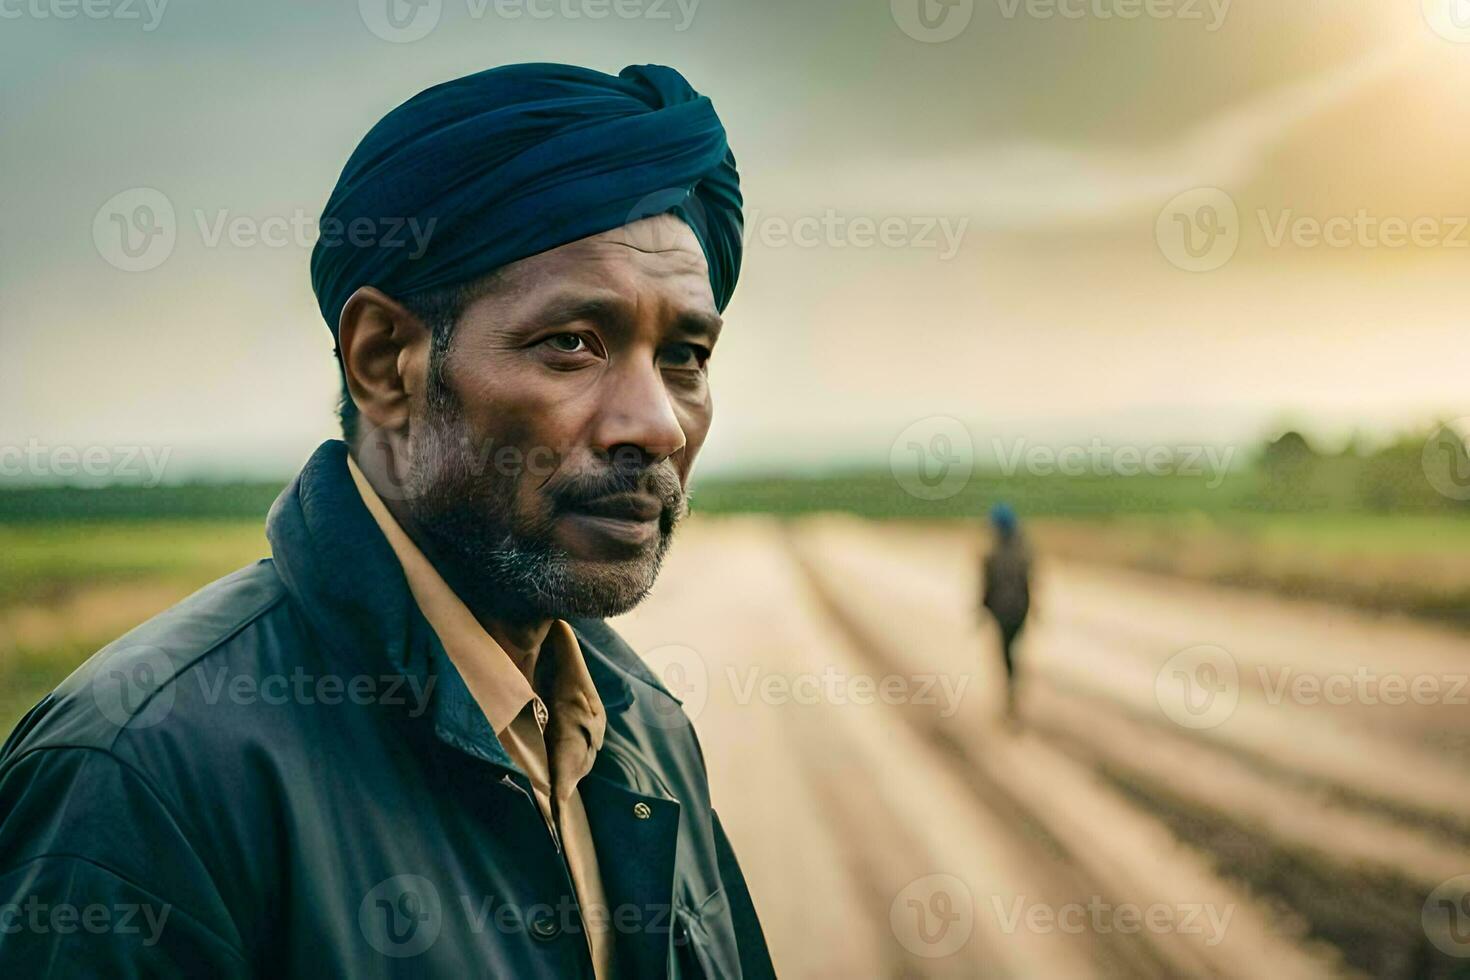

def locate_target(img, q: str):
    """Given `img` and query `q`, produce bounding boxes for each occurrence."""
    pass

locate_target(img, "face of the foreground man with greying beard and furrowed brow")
[406,215,720,617]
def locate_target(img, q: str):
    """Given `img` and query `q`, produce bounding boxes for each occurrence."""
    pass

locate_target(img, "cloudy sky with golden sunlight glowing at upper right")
[0,0,1470,482]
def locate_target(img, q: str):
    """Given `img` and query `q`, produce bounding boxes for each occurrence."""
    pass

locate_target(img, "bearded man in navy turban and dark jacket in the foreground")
[0,65,773,980]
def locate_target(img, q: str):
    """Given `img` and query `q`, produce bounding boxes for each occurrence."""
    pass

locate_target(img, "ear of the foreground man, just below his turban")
[337,287,431,433]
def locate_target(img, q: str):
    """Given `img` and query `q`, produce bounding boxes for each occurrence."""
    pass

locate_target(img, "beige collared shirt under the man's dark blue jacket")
[347,457,614,980]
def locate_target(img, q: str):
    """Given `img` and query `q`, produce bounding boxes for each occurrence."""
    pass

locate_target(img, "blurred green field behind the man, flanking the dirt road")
[0,457,1470,730]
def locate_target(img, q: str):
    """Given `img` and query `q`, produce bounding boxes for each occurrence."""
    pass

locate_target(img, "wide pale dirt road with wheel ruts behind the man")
[617,517,1470,977]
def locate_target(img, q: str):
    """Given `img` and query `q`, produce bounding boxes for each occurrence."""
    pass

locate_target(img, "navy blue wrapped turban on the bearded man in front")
[312,65,742,335]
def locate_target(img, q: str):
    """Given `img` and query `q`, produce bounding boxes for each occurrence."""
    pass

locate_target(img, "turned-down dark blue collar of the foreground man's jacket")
[266,439,637,768]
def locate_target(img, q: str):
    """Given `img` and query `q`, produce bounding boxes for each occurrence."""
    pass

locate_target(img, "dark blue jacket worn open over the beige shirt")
[0,442,773,980]
